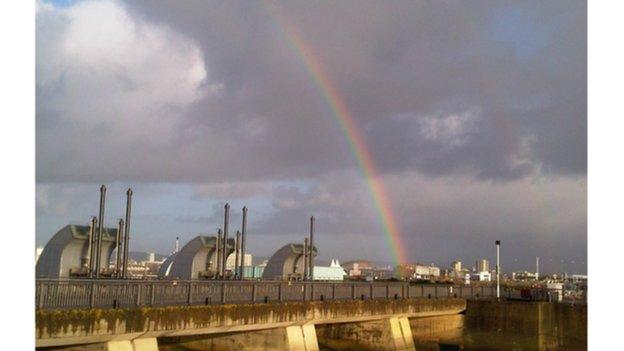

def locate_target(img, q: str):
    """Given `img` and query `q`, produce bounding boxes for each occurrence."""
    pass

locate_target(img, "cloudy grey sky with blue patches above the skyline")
[36,0,587,273]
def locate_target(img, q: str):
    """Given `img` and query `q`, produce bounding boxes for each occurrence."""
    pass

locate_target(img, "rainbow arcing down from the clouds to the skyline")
[264,1,407,264]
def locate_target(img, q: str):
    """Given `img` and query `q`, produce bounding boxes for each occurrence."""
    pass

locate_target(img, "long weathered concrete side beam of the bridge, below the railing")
[36,299,466,347]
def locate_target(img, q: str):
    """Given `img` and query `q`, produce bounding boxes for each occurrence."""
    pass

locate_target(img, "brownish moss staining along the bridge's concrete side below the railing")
[36,298,466,339]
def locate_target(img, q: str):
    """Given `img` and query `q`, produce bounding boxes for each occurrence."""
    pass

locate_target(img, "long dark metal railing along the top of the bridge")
[35,279,496,309]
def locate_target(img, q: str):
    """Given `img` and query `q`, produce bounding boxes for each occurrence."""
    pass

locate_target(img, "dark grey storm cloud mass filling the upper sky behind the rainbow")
[37,1,587,182]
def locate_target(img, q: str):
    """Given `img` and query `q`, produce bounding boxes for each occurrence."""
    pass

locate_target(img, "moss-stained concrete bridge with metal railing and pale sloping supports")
[36,280,493,351]
